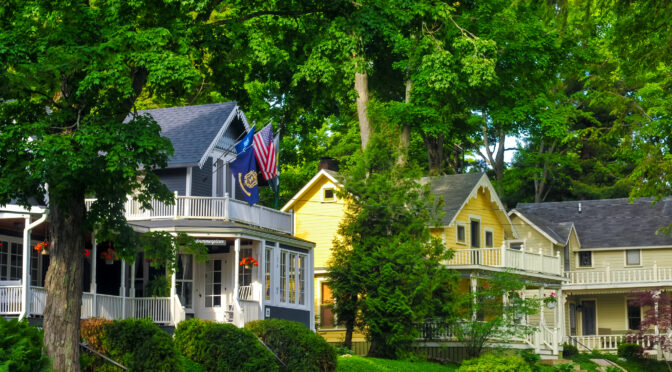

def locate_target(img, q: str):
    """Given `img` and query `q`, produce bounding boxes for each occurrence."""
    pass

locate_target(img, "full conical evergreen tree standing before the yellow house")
[329,128,456,358]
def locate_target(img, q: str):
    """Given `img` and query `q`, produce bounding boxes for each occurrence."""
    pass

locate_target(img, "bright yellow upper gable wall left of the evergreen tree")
[293,176,344,270]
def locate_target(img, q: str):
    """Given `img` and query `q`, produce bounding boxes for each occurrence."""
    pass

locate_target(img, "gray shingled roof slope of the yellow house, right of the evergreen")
[420,173,483,225]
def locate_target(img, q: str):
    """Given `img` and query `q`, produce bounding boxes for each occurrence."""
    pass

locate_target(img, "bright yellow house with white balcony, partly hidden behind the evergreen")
[282,169,564,355]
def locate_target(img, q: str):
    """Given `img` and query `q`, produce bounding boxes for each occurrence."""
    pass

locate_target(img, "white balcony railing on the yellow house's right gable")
[448,247,562,276]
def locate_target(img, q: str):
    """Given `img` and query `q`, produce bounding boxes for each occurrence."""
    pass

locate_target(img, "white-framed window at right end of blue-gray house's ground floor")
[280,250,308,305]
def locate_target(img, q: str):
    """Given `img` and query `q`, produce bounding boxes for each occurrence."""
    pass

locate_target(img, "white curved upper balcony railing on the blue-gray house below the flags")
[86,193,293,234]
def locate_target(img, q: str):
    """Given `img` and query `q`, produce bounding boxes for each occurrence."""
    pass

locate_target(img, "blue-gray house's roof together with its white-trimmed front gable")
[138,102,250,168]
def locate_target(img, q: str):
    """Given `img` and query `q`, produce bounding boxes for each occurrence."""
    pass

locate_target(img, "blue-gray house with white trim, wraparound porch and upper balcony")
[0,102,315,329]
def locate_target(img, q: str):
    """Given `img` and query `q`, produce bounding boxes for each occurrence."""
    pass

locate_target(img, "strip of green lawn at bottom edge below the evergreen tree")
[336,355,458,372]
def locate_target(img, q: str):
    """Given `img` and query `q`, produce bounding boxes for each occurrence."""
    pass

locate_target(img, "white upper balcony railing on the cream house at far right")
[567,264,672,285]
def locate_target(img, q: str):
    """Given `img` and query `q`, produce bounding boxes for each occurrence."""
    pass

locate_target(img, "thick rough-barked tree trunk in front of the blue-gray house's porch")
[44,190,86,372]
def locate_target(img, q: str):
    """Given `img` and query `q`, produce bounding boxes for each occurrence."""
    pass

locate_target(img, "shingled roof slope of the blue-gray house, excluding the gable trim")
[133,102,236,168]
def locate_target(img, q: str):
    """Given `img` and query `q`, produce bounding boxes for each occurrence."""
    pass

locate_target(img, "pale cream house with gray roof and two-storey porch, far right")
[509,198,672,350]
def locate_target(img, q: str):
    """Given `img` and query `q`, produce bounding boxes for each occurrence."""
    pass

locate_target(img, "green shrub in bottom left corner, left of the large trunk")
[0,316,50,372]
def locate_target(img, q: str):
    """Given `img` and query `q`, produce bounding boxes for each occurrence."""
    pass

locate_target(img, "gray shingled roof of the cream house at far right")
[516,197,672,248]
